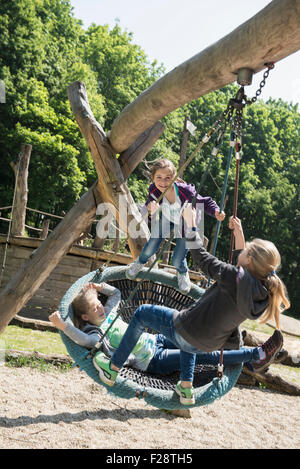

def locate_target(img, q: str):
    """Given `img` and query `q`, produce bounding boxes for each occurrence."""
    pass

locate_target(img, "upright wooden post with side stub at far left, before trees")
[10,144,32,236]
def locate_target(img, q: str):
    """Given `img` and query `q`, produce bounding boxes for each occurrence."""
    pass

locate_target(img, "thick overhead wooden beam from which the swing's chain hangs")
[109,0,300,153]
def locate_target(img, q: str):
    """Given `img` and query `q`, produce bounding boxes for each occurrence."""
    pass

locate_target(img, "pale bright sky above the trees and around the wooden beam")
[70,0,300,105]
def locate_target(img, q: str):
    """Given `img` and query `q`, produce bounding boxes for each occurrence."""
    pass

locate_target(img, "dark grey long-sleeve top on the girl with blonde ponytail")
[174,230,269,352]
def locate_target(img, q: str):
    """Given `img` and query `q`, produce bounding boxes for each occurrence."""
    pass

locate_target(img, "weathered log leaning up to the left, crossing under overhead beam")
[68,81,149,258]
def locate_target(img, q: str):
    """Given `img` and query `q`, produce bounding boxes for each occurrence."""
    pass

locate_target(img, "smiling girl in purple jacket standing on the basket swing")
[127,159,225,293]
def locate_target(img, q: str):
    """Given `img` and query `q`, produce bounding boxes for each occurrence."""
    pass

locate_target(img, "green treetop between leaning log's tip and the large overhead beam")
[84,24,163,130]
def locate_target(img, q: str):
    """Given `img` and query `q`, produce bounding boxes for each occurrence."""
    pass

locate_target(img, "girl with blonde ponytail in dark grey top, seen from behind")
[94,206,289,405]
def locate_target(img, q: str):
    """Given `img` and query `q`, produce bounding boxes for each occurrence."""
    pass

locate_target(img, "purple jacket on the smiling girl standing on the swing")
[145,182,220,217]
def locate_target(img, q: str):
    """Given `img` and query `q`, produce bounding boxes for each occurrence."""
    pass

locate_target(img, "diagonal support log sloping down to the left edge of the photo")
[0,184,101,334]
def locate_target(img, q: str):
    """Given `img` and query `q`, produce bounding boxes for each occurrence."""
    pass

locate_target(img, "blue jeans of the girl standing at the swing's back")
[138,217,188,274]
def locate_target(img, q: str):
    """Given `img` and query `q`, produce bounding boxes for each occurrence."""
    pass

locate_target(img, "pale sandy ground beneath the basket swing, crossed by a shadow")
[0,366,300,449]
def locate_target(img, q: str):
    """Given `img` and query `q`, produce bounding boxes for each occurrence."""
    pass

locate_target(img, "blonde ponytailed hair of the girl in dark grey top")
[246,238,290,329]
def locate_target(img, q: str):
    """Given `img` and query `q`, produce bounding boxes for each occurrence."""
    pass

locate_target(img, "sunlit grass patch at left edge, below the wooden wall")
[0,326,68,355]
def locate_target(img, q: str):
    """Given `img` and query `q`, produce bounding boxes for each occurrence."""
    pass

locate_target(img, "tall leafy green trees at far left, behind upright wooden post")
[0,0,105,213]
